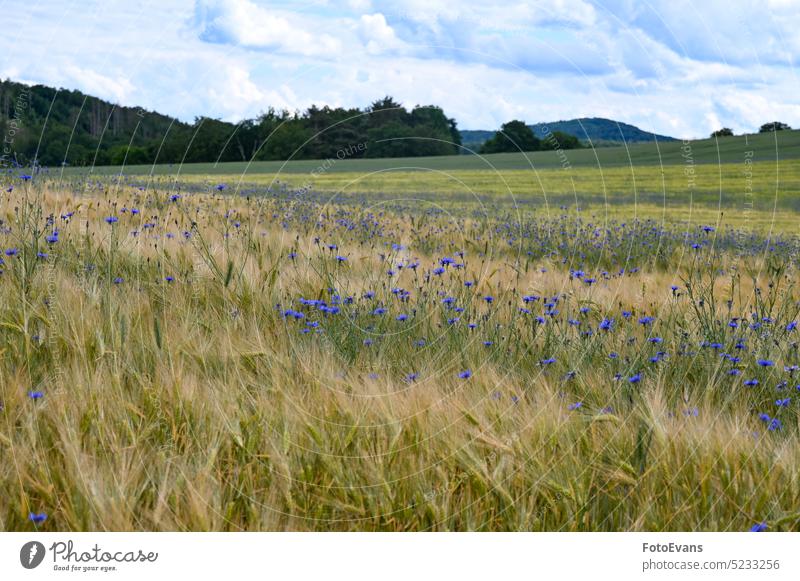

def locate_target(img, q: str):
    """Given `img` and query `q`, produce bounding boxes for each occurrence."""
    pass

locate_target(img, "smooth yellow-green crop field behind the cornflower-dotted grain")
[59,131,800,233]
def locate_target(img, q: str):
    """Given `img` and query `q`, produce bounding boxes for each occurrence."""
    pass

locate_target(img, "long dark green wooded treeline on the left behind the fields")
[0,81,461,166]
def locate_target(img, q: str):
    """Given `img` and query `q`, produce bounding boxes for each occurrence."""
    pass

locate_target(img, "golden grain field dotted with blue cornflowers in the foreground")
[0,174,800,531]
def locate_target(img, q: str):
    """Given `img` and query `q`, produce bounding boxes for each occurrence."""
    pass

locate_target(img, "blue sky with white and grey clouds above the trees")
[0,0,800,138]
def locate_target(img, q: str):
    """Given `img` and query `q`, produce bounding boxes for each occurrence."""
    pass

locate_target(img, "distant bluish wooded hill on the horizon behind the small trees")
[461,117,676,150]
